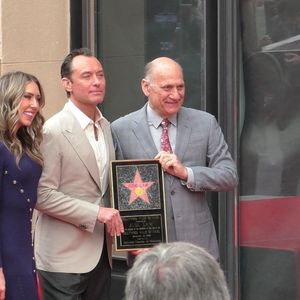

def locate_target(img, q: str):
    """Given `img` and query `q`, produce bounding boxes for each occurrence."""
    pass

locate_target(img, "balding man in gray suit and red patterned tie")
[111,57,238,263]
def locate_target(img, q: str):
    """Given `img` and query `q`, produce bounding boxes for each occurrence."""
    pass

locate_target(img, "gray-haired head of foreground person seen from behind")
[125,242,230,300]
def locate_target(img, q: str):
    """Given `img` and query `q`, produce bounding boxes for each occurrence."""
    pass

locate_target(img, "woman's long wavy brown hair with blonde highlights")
[0,71,45,165]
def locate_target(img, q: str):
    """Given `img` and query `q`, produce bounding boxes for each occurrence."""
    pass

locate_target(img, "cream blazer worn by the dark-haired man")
[35,106,115,273]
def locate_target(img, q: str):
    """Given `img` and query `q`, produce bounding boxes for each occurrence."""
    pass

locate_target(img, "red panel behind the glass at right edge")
[240,197,300,250]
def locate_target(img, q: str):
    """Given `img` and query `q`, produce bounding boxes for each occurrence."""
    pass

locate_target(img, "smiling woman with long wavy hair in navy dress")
[0,71,45,300]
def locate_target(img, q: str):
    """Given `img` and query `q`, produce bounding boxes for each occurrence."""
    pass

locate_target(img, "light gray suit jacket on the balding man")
[111,105,238,258]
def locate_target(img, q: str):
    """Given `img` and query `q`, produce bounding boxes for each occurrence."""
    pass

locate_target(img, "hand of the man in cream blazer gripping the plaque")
[98,207,124,236]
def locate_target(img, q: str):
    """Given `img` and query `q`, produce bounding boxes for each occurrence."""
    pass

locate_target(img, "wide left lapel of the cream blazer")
[63,107,101,190]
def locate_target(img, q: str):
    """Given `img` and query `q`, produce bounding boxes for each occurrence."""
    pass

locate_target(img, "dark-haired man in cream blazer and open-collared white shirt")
[35,49,124,300]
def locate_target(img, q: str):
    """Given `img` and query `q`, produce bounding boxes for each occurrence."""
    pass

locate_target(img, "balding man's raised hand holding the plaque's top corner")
[155,151,188,180]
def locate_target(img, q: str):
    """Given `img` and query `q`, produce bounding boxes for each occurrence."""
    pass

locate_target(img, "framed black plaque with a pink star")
[110,159,167,251]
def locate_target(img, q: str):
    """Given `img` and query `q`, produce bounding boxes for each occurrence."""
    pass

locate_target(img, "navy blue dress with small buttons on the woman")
[0,143,42,300]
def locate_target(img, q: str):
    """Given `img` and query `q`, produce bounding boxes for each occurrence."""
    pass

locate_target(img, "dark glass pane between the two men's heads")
[99,0,146,121]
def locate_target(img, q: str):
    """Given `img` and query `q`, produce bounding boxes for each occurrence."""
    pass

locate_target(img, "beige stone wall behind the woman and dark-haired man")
[0,0,70,118]
